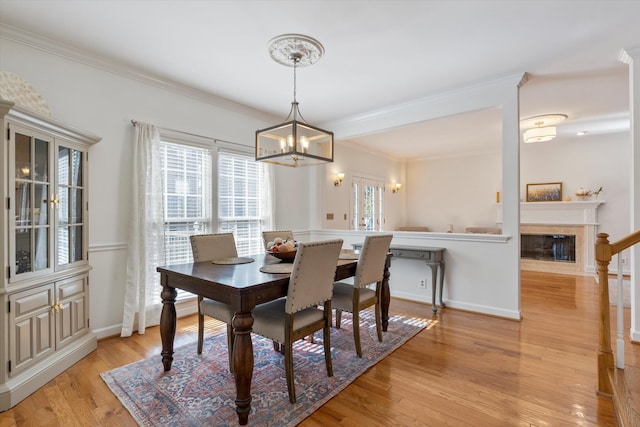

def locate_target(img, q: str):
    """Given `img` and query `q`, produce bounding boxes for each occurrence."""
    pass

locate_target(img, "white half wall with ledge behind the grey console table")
[308,230,520,320]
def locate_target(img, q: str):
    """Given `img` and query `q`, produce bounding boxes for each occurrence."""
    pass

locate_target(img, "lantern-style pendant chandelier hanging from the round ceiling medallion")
[256,34,333,167]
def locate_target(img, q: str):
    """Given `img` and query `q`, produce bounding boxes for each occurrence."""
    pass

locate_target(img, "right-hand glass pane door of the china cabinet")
[57,146,84,266]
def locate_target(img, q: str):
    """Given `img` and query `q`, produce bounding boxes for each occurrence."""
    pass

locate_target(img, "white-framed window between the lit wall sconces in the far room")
[351,176,385,231]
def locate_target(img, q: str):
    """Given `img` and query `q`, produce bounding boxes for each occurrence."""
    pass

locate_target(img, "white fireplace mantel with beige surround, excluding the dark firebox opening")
[497,200,604,275]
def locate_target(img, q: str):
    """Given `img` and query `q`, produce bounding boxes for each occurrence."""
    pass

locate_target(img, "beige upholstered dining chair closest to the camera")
[252,239,342,403]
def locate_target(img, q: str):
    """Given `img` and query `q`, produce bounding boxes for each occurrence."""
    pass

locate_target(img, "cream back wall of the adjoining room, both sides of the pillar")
[403,132,632,244]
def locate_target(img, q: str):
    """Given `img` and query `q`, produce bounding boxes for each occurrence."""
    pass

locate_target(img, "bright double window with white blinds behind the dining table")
[160,141,269,264]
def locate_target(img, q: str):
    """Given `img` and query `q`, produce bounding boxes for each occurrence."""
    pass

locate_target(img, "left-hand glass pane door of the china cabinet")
[13,131,51,275]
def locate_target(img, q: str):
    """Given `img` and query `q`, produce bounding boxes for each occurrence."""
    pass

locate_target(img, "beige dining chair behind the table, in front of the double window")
[189,233,238,372]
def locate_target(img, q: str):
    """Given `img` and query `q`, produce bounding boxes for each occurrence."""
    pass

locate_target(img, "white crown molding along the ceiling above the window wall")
[0,24,281,122]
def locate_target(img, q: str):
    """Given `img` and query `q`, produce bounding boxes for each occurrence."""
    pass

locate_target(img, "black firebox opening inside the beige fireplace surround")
[520,234,576,263]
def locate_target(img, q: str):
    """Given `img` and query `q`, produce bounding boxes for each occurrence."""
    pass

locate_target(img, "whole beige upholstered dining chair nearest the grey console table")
[331,234,393,357]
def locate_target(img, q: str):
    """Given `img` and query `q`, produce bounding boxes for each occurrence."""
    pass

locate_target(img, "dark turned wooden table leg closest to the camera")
[232,312,253,425]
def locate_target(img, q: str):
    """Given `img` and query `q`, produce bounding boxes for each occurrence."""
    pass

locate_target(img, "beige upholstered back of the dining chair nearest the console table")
[353,234,393,288]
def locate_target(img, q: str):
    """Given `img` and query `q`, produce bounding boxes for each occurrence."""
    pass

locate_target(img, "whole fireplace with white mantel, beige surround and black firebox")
[497,200,604,275]
